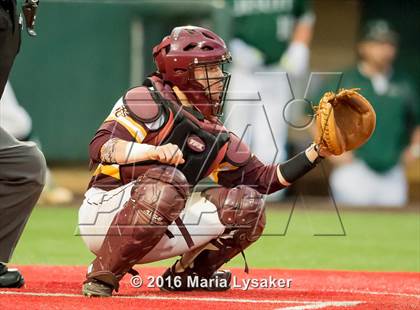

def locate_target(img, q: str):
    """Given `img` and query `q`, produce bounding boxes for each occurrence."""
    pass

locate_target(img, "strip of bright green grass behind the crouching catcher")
[12,207,420,272]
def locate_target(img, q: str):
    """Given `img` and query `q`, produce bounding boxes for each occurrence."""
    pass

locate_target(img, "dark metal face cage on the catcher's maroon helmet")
[188,59,231,117]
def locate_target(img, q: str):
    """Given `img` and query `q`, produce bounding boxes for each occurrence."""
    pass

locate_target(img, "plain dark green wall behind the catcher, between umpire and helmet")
[11,0,229,161]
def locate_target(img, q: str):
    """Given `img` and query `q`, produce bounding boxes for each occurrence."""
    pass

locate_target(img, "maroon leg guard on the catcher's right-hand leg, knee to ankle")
[164,186,265,290]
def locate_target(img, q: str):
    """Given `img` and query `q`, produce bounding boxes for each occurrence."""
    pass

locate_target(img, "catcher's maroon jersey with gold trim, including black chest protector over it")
[89,76,284,194]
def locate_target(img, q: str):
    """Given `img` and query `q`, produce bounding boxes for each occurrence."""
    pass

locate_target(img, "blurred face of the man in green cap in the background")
[359,41,397,69]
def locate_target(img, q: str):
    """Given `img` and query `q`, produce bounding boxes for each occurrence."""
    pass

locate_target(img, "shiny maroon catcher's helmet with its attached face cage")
[153,26,231,116]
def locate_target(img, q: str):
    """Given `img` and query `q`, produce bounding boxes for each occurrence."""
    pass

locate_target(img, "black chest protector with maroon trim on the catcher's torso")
[124,79,230,185]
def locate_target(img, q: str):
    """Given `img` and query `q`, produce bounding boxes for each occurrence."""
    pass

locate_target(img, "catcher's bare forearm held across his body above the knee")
[100,138,155,165]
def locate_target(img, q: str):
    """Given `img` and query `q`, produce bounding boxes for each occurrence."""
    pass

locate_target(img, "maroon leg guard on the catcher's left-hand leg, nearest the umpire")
[87,166,189,290]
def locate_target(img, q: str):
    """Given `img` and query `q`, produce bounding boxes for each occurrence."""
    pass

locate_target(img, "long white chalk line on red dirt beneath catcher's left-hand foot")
[0,291,363,309]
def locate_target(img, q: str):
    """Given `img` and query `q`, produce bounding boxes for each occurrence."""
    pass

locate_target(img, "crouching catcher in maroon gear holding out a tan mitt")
[79,26,374,296]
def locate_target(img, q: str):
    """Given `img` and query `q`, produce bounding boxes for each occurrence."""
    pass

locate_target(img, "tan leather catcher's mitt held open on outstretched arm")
[315,89,376,155]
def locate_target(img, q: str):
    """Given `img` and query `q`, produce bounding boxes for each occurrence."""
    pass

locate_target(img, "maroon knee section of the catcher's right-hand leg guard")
[202,185,265,243]
